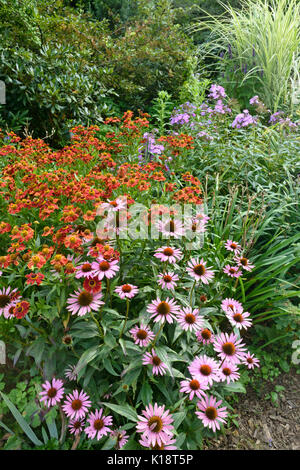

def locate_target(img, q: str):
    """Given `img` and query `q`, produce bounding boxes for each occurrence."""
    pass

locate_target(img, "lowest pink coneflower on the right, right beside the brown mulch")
[196,396,228,432]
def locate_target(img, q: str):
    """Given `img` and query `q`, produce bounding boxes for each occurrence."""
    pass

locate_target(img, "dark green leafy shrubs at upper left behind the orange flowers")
[0,0,192,145]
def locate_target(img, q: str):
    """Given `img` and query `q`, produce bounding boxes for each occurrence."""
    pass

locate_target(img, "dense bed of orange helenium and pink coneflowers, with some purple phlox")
[0,86,298,449]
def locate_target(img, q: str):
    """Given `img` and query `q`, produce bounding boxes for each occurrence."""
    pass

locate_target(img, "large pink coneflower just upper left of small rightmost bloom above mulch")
[214,333,245,364]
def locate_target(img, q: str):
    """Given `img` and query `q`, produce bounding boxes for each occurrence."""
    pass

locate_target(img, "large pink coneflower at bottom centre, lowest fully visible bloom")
[136,403,174,446]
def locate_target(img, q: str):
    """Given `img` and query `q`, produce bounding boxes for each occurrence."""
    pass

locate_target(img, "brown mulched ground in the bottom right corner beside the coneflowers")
[205,371,300,450]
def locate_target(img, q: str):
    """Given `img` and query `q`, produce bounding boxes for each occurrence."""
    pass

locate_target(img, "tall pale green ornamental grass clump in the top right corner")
[195,0,300,111]
